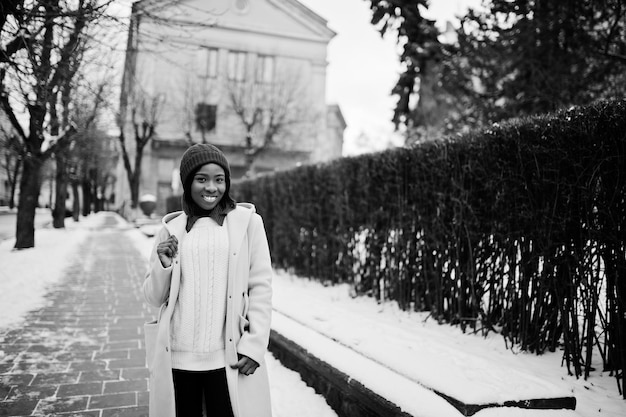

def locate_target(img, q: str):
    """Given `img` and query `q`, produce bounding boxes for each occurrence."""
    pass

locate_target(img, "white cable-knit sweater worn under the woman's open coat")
[171,217,228,371]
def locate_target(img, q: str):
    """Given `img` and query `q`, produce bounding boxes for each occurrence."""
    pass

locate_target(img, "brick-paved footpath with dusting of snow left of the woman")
[0,217,154,417]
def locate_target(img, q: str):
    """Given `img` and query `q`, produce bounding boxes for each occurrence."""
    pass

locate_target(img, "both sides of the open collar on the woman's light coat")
[161,203,256,248]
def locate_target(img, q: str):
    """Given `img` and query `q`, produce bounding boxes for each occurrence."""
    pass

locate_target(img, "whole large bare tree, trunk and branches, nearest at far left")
[0,0,111,249]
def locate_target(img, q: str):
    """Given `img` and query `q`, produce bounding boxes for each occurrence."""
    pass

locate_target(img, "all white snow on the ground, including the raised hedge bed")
[0,214,626,417]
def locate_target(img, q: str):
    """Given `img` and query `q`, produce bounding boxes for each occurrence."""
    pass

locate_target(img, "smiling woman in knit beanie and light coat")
[143,144,272,417]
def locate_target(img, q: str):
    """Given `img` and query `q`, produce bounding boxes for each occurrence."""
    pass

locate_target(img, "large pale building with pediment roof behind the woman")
[116,0,346,214]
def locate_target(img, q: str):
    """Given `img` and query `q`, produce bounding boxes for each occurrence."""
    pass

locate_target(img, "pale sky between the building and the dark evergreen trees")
[299,0,480,156]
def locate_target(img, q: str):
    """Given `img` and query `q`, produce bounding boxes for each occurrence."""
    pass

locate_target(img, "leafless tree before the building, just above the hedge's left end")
[226,69,319,175]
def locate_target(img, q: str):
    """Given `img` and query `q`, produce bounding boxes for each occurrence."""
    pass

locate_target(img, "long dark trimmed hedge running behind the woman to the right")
[234,100,626,394]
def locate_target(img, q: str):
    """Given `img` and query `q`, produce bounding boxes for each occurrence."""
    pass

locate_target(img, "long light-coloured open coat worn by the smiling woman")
[143,203,273,417]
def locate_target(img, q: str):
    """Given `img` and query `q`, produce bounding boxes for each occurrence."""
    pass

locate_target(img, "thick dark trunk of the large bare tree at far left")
[14,156,43,249]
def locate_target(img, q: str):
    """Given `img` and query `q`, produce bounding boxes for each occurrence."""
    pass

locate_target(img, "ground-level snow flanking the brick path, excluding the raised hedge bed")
[0,213,337,417]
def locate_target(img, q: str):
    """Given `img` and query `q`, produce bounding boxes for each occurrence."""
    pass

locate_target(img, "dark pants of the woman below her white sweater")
[172,369,233,417]
